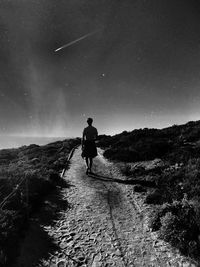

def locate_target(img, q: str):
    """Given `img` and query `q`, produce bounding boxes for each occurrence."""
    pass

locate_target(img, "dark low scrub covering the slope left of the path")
[0,138,80,266]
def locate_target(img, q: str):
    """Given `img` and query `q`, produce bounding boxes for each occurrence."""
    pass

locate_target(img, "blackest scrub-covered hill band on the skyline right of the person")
[99,121,200,162]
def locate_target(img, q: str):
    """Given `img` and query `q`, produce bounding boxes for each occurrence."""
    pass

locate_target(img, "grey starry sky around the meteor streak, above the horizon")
[0,0,200,136]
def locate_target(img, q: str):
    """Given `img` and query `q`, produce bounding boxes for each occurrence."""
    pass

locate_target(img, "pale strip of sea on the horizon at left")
[0,135,66,150]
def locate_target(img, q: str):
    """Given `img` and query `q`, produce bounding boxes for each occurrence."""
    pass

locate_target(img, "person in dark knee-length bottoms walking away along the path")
[82,118,98,174]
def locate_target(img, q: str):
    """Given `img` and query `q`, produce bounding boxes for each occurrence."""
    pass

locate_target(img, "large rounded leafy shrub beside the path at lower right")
[149,198,200,257]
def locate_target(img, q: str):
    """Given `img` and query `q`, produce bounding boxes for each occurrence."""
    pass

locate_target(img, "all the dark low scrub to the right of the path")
[99,121,200,262]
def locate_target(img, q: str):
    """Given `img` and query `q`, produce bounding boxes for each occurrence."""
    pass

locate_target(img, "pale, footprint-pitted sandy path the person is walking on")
[14,148,196,267]
